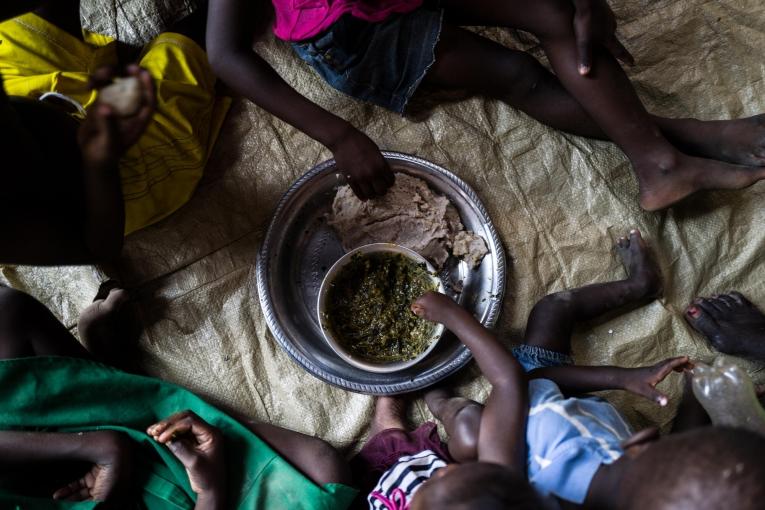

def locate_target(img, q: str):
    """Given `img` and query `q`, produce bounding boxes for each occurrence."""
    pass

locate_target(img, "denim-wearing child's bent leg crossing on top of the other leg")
[424,0,765,210]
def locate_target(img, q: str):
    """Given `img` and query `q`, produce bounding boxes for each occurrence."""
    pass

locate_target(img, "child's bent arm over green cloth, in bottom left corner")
[0,430,131,501]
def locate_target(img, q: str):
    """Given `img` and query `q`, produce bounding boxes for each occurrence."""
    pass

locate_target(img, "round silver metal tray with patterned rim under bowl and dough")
[256,152,505,395]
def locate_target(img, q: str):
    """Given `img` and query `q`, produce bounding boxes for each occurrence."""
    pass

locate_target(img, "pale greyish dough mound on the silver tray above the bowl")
[329,173,488,268]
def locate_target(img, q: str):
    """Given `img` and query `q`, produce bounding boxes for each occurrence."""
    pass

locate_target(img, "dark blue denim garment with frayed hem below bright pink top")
[292,7,443,114]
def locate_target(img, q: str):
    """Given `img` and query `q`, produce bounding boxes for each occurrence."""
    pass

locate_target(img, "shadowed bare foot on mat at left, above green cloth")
[77,288,137,370]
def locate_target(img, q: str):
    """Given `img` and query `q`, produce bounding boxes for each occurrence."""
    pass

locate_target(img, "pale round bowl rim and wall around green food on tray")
[316,243,446,374]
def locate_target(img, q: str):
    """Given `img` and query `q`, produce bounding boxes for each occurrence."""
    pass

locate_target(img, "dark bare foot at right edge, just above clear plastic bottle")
[685,292,765,361]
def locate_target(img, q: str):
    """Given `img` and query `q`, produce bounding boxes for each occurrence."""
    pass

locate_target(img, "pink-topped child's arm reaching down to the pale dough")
[207,0,393,199]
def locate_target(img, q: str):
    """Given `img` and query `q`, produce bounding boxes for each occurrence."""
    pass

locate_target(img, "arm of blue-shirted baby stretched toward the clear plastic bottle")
[528,356,690,406]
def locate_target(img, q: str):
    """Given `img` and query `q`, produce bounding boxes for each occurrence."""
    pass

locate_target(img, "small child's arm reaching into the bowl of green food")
[412,292,528,476]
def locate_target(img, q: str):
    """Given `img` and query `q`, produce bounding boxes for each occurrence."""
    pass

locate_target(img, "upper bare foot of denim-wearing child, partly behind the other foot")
[667,114,765,166]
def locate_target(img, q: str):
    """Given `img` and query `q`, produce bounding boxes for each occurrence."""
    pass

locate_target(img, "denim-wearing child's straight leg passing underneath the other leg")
[426,24,765,166]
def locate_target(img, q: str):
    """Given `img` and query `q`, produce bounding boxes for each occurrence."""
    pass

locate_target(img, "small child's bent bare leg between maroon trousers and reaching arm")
[425,388,483,463]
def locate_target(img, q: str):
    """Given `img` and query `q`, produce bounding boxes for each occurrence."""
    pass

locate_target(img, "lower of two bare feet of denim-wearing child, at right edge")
[634,152,765,211]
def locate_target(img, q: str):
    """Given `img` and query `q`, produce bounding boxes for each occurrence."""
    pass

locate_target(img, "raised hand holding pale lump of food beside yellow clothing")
[77,65,156,166]
